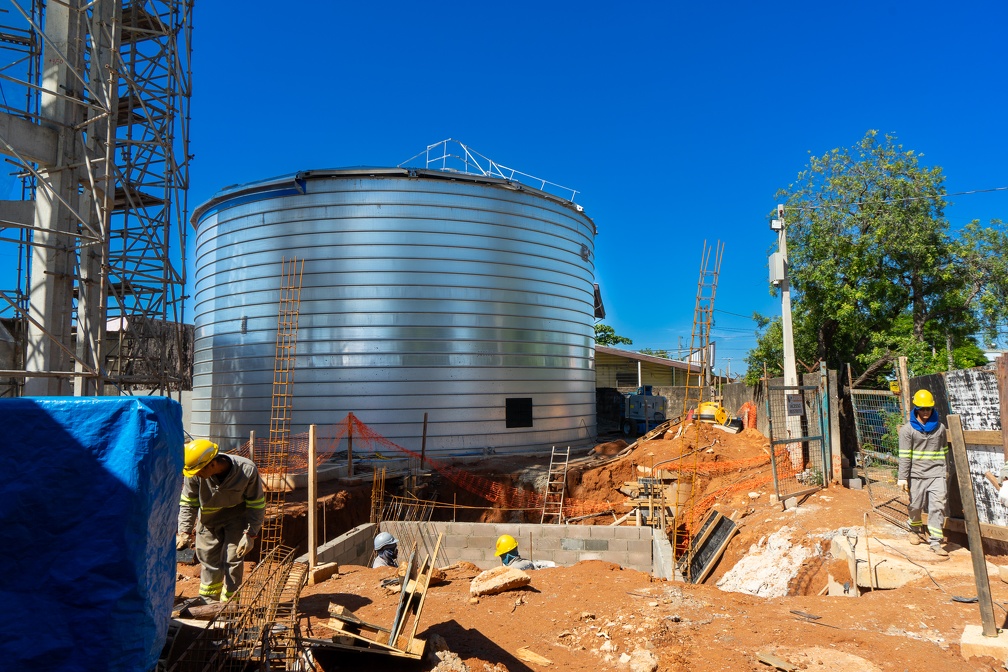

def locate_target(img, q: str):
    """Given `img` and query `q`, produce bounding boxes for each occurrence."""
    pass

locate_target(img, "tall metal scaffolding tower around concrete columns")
[0,0,194,396]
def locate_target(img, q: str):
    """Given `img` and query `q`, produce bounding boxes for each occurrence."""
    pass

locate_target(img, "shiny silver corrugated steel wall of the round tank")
[190,168,596,454]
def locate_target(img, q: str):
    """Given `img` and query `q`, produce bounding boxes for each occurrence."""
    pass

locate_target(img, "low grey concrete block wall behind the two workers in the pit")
[370,521,672,578]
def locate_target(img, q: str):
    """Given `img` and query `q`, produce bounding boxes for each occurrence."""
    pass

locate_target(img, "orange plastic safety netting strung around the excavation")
[235,409,789,530]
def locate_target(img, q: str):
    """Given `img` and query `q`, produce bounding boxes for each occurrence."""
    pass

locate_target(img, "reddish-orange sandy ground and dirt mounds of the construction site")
[176,423,1008,672]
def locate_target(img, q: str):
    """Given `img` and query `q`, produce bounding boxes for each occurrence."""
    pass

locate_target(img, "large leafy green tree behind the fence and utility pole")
[746,131,1008,383]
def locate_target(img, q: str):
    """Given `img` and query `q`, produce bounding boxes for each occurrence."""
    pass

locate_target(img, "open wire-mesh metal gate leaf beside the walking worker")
[851,390,909,527]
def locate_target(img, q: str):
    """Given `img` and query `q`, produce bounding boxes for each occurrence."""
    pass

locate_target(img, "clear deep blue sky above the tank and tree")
[190,0,1008,373]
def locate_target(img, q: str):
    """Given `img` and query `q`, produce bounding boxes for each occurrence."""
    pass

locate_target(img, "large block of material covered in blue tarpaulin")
[0,397,183,672]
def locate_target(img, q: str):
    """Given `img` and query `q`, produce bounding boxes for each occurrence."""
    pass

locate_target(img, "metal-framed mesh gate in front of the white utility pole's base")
[766,374,830,501]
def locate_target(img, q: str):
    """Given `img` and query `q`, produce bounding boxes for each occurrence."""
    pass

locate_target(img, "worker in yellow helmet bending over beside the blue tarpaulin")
[175,438,266,600]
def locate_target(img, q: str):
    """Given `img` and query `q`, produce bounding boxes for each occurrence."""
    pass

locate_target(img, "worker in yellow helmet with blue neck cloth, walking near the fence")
[896,390,949,557]
